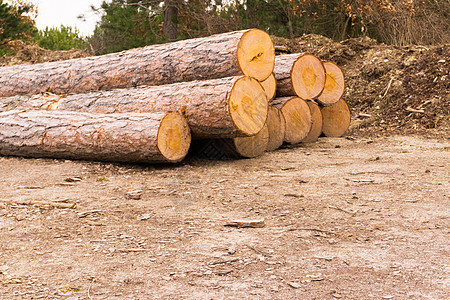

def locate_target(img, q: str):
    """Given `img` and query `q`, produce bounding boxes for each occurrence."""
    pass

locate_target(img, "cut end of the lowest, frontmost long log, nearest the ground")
[157,112,191,162]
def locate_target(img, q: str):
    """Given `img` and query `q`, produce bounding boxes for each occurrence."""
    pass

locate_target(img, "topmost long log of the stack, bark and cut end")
[0,29,275,97]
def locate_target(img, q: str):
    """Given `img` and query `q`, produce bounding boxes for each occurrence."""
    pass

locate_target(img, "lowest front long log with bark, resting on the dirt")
[0,110,191,163]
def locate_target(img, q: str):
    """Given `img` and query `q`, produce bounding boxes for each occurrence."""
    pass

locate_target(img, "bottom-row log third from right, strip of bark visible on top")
[272,97,312,144]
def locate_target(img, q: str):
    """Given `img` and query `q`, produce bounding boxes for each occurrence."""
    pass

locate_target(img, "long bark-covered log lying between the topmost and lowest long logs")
[0,77,268,138]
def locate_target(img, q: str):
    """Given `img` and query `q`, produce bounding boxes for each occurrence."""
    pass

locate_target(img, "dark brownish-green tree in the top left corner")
[0,0,36,47]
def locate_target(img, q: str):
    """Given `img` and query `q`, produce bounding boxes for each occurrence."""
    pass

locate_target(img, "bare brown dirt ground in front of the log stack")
[0,136,450,299]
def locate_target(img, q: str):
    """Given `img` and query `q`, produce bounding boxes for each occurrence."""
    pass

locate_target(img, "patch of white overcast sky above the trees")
[32,0,103,35]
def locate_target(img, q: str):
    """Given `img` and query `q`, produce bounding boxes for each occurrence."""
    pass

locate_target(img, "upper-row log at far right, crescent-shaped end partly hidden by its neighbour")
[317,61,345,106]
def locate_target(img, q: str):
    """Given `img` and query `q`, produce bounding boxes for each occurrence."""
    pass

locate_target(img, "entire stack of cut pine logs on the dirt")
[0,29,350,163]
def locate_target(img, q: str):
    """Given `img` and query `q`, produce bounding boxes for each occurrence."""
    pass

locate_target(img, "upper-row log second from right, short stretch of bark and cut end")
[274,53,326,99]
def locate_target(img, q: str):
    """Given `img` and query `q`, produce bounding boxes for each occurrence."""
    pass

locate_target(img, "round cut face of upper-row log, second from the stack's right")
[291,54,326,99]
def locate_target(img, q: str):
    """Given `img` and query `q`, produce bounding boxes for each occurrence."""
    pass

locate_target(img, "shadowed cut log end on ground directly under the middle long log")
[233,124,269,158]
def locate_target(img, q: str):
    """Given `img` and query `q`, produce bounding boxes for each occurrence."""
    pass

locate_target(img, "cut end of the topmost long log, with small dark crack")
[237,29,275,81]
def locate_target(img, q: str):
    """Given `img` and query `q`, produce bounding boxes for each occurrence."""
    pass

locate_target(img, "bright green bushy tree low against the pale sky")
[35,25,88,50]
